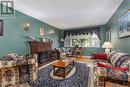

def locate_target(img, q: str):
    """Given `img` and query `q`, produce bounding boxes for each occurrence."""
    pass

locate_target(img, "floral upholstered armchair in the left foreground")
[0,53,36,87]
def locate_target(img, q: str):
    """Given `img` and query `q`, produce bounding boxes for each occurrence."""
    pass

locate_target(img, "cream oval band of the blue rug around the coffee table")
[49,67,76,80]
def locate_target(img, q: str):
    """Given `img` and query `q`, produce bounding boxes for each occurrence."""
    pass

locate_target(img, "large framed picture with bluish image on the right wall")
[118,9,130,38]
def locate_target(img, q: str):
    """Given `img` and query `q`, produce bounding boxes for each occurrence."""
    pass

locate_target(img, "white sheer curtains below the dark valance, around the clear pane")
[64,32,100,47]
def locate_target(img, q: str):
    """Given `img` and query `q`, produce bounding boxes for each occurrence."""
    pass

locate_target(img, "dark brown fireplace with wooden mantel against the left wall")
[28,41,60,66]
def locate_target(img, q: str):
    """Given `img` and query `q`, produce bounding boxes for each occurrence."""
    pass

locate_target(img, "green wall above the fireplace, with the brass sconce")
[0,11,61,57]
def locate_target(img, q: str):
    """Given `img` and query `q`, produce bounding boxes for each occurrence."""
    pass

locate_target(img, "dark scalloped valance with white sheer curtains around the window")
[64,27,100,47]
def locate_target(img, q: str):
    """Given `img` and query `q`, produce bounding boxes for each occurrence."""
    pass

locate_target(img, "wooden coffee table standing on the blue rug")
[52,58,75,78]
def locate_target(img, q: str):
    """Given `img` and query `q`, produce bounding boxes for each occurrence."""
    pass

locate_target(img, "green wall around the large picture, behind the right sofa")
[107,0,130,53]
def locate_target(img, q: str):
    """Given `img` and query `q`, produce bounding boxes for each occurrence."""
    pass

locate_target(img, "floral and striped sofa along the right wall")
[95,51,130,84]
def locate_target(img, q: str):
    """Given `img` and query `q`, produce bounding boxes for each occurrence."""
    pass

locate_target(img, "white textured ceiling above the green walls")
[15,0,123,29]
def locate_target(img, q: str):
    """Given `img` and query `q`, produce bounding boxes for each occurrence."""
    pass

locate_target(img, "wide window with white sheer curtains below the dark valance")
[64,33,100,47]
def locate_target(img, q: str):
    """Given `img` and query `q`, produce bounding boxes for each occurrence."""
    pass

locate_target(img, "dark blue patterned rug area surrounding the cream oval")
[30,62,89,87]
